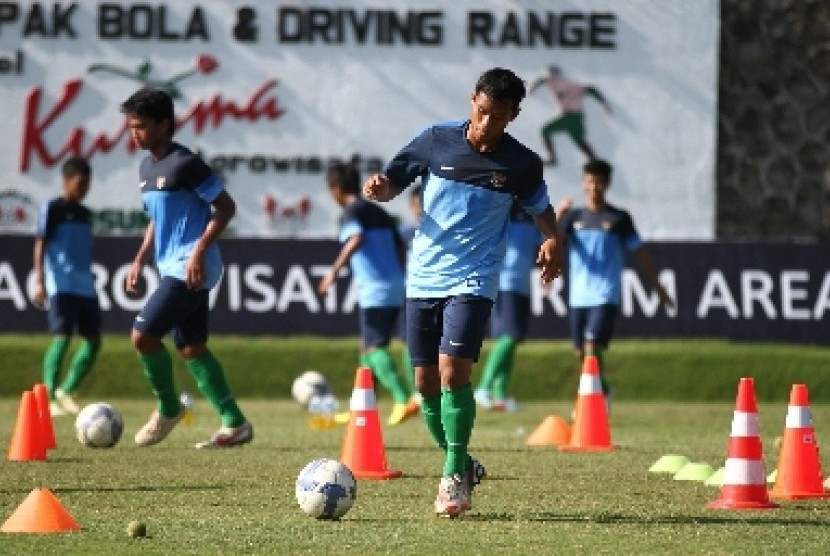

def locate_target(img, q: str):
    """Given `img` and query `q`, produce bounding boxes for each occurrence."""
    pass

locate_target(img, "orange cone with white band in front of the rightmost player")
[559,355,614,452]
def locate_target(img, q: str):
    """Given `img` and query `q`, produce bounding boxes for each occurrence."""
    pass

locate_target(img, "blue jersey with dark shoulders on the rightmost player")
[561,205,643,307]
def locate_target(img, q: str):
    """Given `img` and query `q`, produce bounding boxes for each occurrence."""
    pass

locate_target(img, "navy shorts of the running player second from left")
[133,276,209,348]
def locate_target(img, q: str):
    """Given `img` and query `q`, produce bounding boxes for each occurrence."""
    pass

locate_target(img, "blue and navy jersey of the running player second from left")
[139,143,224,289]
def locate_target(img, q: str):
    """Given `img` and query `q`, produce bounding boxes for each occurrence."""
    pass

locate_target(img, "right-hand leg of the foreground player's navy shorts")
[439,295,493,361]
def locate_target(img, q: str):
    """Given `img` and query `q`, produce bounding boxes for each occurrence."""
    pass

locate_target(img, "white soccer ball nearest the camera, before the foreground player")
[296,459,357,519]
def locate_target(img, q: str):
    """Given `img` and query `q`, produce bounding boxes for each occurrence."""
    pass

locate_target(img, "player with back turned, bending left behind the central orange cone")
[317,164,418,425]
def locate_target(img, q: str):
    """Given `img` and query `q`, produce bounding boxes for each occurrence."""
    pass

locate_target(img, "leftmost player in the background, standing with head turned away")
[34,157,101,415]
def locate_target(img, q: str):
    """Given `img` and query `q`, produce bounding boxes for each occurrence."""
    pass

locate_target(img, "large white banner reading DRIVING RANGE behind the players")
[0,0,719,240]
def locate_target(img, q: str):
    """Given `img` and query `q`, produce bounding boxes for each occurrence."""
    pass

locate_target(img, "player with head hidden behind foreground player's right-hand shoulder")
[475,203,543,411]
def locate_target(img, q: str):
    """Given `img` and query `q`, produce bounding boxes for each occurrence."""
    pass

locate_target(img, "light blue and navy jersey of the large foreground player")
[385,121,549,299]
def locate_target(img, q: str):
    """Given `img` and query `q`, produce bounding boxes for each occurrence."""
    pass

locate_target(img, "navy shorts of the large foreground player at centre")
[406,295,493,367]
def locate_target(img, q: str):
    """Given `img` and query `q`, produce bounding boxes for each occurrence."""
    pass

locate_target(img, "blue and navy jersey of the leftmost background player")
[37,197,97,297]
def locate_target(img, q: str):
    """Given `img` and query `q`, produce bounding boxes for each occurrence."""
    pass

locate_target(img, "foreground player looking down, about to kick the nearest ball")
[363,68,562,517]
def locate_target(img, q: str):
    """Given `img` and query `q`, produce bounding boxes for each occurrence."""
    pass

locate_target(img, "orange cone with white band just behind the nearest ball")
[340,367,403,479]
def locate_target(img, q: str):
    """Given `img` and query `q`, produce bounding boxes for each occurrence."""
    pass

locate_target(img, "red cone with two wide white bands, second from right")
[707,378,778,510]
